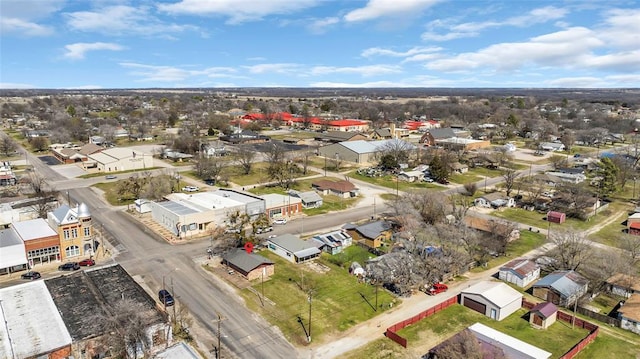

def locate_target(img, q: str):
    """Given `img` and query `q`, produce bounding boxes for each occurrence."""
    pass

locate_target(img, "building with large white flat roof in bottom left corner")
[0,280,71,358]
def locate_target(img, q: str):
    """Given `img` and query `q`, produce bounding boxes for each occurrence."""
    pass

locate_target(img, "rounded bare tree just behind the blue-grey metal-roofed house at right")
[547,230,592,271]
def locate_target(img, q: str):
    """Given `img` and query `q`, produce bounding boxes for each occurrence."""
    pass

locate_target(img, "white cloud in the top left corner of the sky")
[0,0,63,36]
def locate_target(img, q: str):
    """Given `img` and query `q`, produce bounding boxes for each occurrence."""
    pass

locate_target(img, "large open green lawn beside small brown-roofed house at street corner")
[240,251,398,345]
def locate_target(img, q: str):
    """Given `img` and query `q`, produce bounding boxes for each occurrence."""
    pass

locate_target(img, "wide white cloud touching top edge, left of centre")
[158,0,320,24]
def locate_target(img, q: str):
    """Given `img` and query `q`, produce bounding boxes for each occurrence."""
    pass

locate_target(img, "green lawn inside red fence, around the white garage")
[398,304,589,358]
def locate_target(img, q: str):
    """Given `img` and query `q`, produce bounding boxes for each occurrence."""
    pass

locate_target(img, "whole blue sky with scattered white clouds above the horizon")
[0,0,640,88]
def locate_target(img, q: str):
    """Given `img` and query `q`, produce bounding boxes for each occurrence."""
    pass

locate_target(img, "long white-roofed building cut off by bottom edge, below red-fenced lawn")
[422,323,552,359]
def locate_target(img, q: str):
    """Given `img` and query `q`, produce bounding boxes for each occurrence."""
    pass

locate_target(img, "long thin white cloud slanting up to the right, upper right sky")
[422,6,568,41]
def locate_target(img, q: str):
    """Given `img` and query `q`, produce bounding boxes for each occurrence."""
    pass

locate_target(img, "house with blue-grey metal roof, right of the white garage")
[533,270,589,307]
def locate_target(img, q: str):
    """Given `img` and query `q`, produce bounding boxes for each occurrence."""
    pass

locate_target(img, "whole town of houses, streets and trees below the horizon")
[0,87,640,359]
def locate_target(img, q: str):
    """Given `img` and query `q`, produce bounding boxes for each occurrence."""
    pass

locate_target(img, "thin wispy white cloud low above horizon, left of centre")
[119,62,242,83]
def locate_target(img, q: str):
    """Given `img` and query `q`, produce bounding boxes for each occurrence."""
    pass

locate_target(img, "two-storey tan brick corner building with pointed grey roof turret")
[47,203,95,260]
